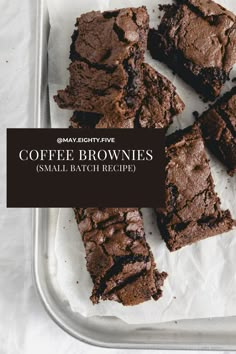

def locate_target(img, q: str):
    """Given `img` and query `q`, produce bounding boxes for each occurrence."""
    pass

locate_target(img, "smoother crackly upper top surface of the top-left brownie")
[71,7,149,67]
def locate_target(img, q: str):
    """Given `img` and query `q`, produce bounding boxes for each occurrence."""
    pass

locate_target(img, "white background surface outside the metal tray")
[0,0,233,354]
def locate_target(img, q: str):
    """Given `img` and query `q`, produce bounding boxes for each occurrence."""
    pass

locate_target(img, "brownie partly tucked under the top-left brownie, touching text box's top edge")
[71,63,185,129]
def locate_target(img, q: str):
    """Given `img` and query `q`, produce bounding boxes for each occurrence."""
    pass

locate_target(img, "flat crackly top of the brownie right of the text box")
[164,125,220,223]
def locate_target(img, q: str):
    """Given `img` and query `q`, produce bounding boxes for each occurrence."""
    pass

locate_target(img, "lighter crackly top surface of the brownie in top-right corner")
[157,0,236,73]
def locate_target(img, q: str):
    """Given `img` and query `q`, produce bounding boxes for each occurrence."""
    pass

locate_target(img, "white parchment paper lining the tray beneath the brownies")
[48,0,236,324]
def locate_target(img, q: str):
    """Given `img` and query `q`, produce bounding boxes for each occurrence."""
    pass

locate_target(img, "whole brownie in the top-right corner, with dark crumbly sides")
[148,0,236,100]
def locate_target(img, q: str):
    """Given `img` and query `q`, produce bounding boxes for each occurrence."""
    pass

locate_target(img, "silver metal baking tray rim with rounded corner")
[33,0,236,351]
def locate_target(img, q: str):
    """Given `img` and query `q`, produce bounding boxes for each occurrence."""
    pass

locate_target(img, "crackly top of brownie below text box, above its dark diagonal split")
[75,208,148,292]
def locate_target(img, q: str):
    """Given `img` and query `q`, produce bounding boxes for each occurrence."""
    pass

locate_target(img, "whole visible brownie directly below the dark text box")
[74,208,167,306]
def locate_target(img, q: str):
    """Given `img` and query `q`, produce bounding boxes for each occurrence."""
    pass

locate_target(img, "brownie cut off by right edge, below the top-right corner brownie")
[197,87,236,176]
